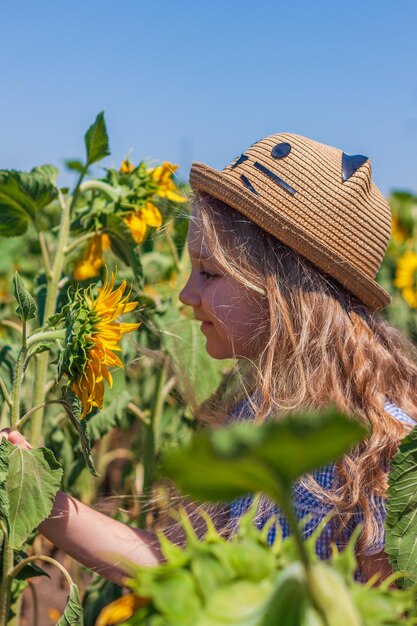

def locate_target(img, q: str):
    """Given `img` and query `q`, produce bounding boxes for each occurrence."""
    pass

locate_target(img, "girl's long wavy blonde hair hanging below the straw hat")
[188,192,417,549]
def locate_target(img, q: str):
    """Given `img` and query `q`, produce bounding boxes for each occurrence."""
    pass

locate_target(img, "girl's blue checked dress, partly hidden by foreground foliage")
[230,402,416,559]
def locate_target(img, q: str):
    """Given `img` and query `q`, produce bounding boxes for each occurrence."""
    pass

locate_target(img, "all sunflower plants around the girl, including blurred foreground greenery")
[0,113,417,626]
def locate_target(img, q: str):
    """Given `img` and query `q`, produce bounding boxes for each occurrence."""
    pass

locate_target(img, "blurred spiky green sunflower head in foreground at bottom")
[118,507,416,626]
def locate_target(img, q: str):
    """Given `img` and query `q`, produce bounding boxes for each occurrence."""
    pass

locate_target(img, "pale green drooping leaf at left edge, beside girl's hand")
[6,444,62,550]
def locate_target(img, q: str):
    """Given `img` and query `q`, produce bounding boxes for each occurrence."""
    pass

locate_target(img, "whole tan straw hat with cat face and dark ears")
[190,133,391,310]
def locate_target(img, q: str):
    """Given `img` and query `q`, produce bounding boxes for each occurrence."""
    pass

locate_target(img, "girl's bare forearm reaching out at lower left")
[39,492,162,585]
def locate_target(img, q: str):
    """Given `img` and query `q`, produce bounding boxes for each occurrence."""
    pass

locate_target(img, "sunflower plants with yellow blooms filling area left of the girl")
[0,113,227,626]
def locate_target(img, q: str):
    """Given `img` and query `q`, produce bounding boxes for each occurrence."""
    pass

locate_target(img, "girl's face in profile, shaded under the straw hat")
[179,220,268,359]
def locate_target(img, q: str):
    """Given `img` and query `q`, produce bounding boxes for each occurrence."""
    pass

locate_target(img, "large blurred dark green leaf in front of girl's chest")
[162,408,366,504]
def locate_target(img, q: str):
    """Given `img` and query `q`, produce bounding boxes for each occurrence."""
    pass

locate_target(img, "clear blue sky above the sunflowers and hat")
[0,0,417,193]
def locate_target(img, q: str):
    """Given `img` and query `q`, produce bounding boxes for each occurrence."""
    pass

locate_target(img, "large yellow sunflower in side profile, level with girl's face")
[66,272,140,419]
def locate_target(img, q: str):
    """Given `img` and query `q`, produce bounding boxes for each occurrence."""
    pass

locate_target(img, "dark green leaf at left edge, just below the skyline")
[0,165,57,237]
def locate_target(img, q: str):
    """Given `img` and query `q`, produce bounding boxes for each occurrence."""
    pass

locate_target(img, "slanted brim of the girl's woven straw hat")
[190,162,391,311]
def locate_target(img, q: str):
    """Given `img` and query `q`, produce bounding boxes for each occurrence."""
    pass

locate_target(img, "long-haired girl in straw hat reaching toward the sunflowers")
[1,134,417,582]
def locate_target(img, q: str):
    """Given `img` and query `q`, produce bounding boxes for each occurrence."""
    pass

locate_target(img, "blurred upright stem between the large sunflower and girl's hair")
[138,356,167,528]
